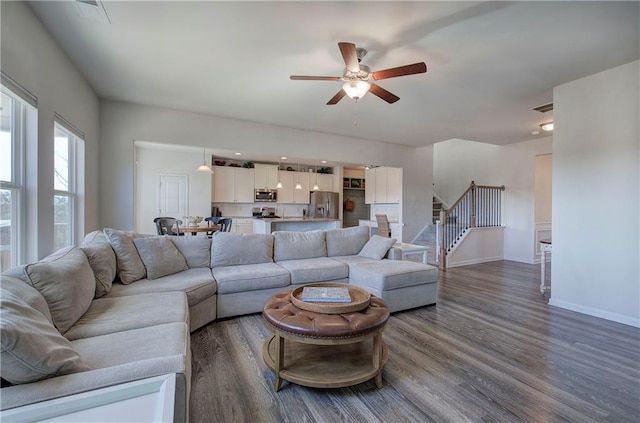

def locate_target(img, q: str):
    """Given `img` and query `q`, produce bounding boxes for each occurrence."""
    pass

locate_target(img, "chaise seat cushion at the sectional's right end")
[349,259,438,291]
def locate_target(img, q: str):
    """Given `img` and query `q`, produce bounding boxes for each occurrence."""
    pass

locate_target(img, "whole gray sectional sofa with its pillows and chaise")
[0,227,438,422]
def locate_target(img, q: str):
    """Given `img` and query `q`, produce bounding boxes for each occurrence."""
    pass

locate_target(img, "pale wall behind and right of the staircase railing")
[433,137,552,263]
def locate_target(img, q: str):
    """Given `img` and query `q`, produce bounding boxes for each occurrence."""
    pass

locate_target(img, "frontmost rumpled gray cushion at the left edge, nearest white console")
[0,288,89,384]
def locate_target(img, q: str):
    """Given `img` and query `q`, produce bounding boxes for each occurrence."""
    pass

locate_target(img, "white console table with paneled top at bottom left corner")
[0,373,176,423]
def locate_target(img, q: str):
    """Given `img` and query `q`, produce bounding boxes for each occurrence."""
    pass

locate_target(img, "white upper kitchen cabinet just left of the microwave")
[211,166,255,203]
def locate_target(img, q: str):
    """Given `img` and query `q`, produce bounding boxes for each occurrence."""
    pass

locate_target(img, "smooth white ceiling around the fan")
[30,1,640,146]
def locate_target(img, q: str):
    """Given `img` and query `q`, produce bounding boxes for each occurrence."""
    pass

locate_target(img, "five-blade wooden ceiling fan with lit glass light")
[290,42,427,106]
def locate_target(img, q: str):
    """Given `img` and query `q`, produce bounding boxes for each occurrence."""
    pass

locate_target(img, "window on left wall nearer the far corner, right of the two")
[53,121,84,250]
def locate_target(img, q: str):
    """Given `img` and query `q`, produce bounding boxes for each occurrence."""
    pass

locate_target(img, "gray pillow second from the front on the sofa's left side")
[24,247,96,334]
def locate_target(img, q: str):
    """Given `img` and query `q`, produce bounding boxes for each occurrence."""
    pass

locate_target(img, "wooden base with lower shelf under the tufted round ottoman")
[262,328,389,391]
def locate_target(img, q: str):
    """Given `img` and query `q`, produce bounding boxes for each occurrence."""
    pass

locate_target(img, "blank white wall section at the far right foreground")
[550,61,640,326]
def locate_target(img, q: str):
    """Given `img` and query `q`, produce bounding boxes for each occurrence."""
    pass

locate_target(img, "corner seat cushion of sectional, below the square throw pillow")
[103,267,217,307]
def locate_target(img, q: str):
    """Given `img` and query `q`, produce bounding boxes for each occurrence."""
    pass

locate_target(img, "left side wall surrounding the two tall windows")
[0,1,102,261]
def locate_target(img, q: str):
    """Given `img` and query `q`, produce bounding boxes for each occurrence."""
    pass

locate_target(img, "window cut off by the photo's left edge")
[0,86,27,270]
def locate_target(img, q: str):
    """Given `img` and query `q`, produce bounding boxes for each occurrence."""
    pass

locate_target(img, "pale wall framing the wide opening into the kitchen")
[100,101,432,243]
